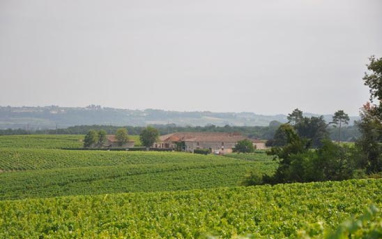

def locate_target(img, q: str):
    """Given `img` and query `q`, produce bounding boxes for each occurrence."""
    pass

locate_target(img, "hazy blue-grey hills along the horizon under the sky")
[0,105,359,130]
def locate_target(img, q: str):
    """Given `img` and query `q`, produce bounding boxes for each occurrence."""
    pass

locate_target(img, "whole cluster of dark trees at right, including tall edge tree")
[243,57,382,185]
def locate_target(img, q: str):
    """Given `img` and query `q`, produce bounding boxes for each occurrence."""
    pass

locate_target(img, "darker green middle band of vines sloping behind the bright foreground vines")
[0,160,275,200]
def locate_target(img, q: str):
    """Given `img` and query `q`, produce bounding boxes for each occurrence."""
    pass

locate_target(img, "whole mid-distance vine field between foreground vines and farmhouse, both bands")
[0,149,276,200]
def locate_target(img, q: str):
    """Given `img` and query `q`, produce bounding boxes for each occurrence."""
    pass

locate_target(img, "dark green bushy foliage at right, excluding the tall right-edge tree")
[263,128,356,184]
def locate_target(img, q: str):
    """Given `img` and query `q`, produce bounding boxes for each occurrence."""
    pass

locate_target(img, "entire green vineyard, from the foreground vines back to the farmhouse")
[0,135,382,238]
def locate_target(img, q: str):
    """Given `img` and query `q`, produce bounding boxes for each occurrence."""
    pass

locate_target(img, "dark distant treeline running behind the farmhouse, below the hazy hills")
[0,121,360,142]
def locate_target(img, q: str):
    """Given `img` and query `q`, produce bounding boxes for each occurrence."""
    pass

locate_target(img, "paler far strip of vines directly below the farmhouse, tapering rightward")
[0,149,271,171]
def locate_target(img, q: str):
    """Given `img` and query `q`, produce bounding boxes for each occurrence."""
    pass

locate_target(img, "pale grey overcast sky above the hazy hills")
[0,0,382,115]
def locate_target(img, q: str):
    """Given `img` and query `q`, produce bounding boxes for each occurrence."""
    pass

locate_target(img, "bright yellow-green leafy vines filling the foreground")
[0,180,382,238]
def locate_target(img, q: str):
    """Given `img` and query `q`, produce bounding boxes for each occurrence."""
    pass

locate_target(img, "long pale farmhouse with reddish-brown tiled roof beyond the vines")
[153,132,256,154]
